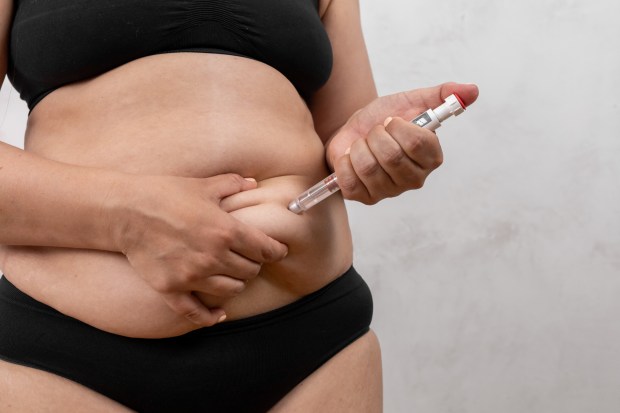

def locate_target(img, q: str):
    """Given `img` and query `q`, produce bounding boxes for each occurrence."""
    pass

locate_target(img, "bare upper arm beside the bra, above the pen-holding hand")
[310,0,377,142]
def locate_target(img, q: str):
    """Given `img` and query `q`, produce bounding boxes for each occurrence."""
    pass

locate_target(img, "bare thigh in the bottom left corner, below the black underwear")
[0,360,131,413]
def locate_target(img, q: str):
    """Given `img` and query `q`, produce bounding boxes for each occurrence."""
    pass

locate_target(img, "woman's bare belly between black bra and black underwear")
[3,0,352,337]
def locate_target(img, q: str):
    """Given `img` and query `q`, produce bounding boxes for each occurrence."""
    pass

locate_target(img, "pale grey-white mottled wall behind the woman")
[0,0,620,413]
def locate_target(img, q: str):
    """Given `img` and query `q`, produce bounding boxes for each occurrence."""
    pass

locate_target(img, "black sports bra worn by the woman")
[7,0,332,110]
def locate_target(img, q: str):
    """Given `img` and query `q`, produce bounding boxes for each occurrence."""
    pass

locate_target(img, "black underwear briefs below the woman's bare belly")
[0,268,372,413]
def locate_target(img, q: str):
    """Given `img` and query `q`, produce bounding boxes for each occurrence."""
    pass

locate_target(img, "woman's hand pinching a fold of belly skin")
[108,174,288,326]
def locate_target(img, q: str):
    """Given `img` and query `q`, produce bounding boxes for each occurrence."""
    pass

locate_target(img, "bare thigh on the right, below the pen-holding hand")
[271,330,383,413]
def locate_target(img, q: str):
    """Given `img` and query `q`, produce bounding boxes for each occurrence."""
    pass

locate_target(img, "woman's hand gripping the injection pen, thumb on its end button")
[326,83,478,204]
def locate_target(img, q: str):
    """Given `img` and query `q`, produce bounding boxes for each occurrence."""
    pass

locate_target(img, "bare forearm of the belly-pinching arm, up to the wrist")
[0,142,124,251]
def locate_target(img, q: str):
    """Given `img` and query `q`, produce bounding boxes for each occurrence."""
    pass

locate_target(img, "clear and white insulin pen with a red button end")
[288,94,465,214]
